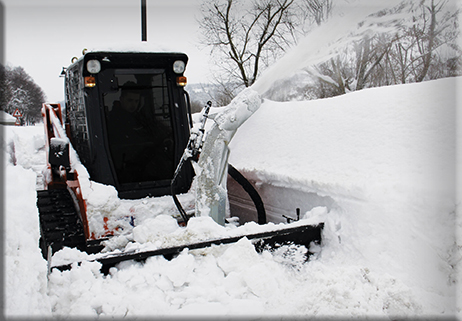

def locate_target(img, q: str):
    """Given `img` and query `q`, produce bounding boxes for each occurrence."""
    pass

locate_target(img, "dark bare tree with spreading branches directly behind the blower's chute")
[200,0,297,91]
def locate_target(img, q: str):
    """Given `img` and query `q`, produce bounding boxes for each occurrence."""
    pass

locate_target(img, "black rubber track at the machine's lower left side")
[37,189,86,259]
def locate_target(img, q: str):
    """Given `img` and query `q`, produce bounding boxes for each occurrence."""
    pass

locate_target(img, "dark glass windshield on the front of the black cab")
[103,69,175,184]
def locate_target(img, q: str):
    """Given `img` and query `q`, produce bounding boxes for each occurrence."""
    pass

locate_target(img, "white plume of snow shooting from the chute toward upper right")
[252,0,416,95]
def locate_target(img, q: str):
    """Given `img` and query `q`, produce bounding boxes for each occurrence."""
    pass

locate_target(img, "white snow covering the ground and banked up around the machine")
[3,78,462,319]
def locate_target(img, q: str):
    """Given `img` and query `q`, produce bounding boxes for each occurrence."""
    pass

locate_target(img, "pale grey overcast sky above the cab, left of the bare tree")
[0,0,209,102]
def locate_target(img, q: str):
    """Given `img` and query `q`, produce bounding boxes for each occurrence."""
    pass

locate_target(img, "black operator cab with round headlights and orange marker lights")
[65,52,194,198]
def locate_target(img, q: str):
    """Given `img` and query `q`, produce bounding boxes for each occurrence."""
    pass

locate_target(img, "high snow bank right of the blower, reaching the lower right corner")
[230,78,461,314]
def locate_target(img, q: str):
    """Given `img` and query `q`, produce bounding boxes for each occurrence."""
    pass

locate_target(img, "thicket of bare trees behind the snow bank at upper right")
[308,0,462,97]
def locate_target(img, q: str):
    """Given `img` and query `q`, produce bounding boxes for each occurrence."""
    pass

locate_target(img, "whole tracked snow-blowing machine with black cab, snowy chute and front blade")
[37,51,323,272]
